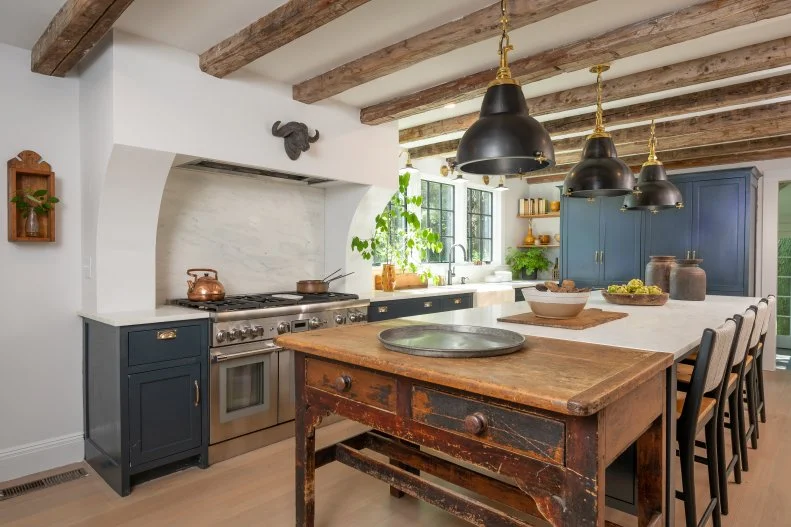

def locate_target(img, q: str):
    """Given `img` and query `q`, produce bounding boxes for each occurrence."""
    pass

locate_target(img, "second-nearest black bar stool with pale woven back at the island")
[678,306,757,514]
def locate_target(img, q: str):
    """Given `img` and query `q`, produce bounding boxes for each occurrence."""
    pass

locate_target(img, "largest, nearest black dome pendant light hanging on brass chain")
[456,0,555,177]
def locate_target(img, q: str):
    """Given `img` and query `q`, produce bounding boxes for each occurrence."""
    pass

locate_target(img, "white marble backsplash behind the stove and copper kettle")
[157,169,324,303]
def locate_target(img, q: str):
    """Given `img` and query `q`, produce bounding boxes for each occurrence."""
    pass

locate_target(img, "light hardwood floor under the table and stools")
[0,371,791,527]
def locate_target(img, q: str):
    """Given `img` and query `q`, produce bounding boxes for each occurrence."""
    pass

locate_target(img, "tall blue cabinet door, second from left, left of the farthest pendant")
[598,197,644,286]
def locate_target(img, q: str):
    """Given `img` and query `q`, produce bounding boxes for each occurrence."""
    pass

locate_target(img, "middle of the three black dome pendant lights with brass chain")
[563,64,635,198]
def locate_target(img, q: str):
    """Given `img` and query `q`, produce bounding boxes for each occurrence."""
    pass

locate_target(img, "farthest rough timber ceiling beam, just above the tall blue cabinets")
[525,135,791,183]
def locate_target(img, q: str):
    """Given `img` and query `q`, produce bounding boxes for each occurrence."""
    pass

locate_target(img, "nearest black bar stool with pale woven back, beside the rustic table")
[676,319,738,527]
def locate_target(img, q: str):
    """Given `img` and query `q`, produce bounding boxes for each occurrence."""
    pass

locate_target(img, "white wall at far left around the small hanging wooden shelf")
[0,44,83,481]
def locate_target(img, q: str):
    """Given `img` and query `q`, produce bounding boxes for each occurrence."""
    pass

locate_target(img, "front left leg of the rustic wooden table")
[294,353,316,527]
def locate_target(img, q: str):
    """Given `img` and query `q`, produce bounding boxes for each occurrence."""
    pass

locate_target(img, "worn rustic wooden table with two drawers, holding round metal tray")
[277,321,675,527]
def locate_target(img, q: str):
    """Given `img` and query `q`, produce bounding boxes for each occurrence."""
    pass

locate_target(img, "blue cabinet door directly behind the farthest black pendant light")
[642,182,694,269]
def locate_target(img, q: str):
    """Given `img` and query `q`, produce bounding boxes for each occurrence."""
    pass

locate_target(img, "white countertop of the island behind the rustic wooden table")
[407,292,760,359]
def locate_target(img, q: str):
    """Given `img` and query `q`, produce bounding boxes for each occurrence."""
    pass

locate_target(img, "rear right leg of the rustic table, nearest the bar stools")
[637,416,665,527]
